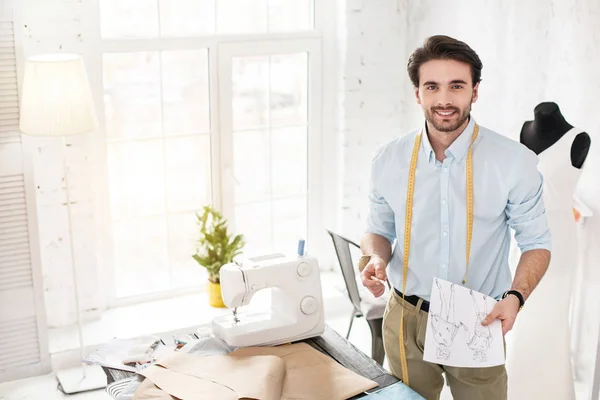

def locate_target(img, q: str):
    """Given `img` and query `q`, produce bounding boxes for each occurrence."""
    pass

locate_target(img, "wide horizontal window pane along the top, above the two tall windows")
[99,0,315,39]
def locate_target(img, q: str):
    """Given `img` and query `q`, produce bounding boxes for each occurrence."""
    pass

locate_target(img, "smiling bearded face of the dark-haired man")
[415,60,479,132]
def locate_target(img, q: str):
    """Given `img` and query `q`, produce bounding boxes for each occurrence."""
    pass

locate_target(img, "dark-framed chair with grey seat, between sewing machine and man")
[327,230,387,365]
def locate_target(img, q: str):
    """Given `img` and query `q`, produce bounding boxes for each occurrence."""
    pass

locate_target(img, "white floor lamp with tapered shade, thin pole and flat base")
[20,53,106,394]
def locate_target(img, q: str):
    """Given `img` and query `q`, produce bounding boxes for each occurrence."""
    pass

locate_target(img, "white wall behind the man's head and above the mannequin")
[341,0,600,238]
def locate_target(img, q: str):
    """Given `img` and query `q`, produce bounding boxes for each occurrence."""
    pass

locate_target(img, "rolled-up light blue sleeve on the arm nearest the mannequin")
[506,151,552,253]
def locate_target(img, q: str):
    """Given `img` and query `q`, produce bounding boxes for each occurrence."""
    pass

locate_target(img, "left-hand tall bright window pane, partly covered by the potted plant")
[103,49,212,297]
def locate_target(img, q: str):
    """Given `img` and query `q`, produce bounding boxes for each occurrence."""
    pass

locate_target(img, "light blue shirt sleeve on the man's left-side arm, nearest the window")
[365,152,396,244]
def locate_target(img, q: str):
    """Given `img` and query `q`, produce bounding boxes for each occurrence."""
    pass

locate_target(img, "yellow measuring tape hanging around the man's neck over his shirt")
[400,124,479,386]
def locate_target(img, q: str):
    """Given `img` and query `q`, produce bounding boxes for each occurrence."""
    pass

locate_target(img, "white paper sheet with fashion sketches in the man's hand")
[423,278,505,368]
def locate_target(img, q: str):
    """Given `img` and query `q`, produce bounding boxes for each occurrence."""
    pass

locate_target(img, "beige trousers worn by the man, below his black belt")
[383,290,508,400]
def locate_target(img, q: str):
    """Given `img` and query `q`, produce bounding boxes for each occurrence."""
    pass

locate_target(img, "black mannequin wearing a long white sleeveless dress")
[506,103,591,400]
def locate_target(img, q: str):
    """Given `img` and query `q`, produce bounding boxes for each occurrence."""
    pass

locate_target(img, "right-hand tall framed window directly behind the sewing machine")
[219,40,320,253]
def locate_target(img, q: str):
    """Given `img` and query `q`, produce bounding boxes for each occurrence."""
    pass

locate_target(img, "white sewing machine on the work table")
[212,254,325,347]
